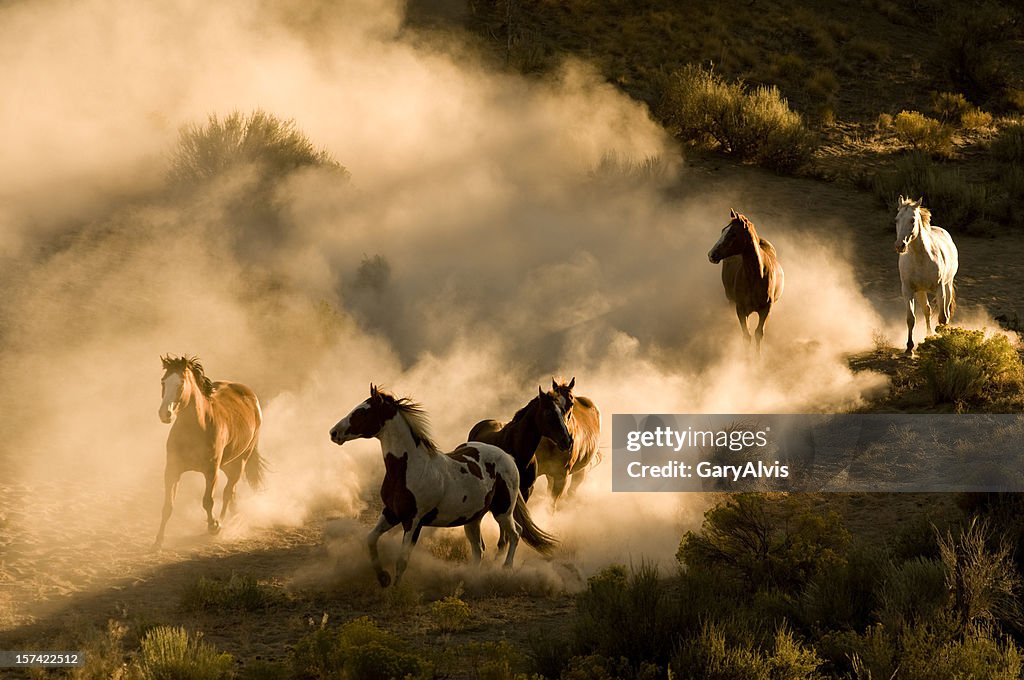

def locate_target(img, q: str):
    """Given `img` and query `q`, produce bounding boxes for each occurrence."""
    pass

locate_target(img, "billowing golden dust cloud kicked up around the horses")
[0,0,937,598]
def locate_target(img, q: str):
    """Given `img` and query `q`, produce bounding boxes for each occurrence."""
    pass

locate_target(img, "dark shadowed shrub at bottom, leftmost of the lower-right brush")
[574,562,679,666]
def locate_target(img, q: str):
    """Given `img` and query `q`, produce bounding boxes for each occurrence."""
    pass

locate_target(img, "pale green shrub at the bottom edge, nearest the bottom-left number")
[139,626,234,680]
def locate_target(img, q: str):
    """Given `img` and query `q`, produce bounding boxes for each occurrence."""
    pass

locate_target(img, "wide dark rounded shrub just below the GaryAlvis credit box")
[676,494,849,592]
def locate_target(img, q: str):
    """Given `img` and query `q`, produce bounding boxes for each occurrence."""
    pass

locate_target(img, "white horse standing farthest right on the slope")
[896,196,959,354]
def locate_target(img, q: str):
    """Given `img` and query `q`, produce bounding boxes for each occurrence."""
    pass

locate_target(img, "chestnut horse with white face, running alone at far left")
[156,356,266,548]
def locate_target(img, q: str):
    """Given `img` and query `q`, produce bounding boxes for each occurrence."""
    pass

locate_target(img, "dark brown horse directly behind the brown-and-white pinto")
[467,387,572,501]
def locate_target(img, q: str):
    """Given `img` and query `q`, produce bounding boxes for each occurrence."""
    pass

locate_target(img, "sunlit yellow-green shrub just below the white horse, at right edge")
[918,326,1024,403]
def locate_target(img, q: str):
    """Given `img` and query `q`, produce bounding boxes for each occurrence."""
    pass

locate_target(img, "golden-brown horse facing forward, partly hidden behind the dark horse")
[536,378,601,505]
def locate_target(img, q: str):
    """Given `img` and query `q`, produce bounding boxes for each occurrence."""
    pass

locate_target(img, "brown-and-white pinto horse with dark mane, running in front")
[331,385,557,588]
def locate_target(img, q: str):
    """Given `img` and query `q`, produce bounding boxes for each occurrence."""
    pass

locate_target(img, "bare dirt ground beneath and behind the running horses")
[0,161,1024,677]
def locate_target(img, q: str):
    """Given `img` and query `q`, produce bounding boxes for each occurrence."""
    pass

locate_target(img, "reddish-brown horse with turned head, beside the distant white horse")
[708,210,785,354]
